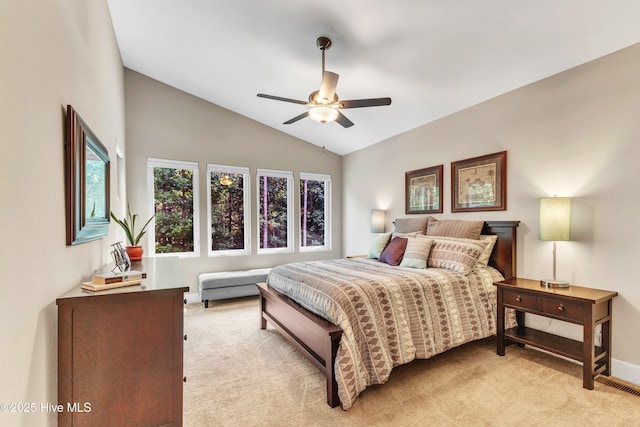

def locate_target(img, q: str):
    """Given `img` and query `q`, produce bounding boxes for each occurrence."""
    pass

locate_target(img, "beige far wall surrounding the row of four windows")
[125,69,342,298]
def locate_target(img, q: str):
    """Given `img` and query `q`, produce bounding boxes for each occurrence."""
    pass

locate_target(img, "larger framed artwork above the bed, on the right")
[451,151,507,212]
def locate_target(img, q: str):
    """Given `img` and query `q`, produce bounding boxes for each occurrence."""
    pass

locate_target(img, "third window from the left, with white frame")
[257,169,293,253]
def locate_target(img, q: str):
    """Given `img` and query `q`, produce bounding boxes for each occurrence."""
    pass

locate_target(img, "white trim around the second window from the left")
[207,163,251,257]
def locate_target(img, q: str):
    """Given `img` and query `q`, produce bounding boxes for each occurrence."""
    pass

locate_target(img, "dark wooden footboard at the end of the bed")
[257,283,342,408]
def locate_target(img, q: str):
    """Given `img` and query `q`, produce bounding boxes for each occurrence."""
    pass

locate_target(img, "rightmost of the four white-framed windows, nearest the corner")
[300,173,331,252]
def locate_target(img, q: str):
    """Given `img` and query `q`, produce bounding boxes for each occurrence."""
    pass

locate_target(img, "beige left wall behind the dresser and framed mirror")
[0,0,125,426]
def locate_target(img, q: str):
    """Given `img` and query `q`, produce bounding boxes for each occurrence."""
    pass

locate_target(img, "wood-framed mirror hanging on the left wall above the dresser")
[65,105,110,245]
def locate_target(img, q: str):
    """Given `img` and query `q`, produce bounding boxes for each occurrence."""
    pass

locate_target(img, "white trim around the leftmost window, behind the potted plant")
[147,157,200,258]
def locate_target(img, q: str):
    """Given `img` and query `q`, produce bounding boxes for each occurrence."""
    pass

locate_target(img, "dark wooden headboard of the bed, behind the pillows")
[482,221,520,279]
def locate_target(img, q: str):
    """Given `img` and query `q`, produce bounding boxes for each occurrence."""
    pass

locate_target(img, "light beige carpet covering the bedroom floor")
[184,297,640,427]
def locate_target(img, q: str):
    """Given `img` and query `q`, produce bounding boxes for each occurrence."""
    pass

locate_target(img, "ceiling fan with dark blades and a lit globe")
[258,37,391,128]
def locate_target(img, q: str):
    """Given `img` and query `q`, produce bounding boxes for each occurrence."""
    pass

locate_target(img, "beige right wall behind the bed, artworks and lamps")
[343,45,640,383]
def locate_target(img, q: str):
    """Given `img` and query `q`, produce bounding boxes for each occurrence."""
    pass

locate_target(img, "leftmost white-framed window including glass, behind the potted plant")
[147,159,200,256]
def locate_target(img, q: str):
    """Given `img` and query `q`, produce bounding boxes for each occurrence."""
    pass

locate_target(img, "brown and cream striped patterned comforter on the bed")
[267,259,502,410]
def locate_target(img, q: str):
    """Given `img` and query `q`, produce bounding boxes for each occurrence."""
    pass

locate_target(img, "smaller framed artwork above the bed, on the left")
[404,165,443,214]
